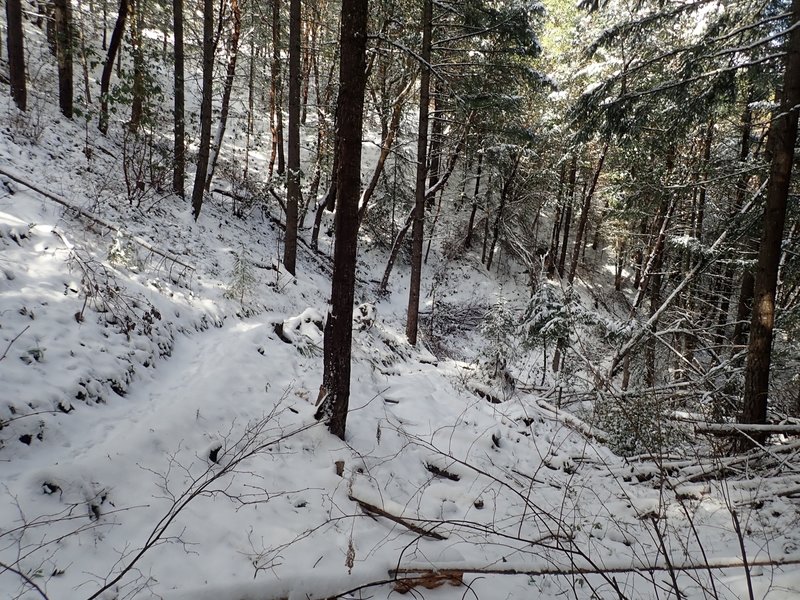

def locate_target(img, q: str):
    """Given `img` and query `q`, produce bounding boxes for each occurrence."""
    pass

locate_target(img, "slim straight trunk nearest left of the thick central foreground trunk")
[283,0,301,275]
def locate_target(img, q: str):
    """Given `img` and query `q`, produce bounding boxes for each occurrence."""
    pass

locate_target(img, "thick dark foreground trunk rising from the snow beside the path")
[316,0,368,439]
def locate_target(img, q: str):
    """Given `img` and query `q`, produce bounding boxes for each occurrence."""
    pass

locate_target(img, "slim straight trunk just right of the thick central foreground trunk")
[406,0,433,346]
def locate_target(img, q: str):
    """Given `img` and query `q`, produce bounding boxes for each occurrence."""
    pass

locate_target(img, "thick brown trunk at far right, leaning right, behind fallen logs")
[741,0,800,432]
